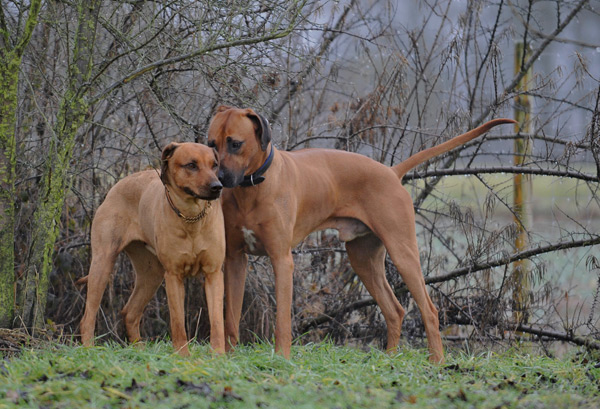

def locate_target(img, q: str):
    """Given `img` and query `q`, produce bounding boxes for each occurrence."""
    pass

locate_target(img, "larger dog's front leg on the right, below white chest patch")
[271,250,294,359]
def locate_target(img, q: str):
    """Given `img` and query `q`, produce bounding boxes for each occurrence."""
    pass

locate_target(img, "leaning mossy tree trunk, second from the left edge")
[21,0,101,329]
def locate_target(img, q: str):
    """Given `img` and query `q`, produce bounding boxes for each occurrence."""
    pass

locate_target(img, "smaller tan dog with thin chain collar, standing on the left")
[81,143,225,355]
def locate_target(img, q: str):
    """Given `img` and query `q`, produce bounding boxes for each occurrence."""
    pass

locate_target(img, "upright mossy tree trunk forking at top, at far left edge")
[0,0,41,327]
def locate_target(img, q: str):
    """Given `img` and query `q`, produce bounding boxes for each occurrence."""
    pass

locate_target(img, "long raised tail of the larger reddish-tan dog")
[392,118,517,179]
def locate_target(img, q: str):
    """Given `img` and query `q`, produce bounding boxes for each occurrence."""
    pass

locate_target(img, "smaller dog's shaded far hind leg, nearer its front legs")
[121,241,164,342]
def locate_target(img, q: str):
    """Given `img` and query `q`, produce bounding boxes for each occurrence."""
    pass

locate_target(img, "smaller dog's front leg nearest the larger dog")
[204,268,225,354]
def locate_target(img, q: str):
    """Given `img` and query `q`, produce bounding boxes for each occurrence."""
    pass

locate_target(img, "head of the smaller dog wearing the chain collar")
[160,142,223,200]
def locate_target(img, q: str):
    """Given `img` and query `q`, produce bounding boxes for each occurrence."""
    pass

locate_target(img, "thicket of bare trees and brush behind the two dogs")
[0,0,600,346]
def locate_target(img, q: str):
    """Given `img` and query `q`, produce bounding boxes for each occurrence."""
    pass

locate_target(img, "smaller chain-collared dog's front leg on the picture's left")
[165,271,190,356]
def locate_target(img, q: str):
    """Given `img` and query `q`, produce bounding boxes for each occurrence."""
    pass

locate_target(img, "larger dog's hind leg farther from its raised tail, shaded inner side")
[346,233,404,351]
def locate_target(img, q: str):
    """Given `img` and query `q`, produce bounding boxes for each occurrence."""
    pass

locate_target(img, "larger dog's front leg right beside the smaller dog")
[223,250,248,351]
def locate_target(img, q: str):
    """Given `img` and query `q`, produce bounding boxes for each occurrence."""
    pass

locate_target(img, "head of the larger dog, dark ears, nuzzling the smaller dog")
[208,106,271,187]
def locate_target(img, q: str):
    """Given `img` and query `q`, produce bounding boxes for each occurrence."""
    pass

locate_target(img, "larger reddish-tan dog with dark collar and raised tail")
[208,107,514,362]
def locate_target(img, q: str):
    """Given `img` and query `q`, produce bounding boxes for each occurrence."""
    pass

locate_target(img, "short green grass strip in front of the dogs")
[0,342,600,409]
